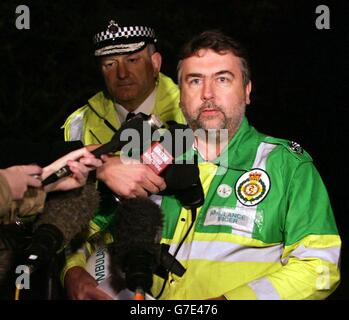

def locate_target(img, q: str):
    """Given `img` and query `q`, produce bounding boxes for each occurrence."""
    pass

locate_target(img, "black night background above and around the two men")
[0,0,349,299]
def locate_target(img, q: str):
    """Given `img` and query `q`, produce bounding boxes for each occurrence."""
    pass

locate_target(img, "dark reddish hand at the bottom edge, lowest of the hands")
[64,267,113,300]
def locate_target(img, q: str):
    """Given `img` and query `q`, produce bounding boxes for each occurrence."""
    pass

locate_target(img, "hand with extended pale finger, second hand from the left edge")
[41,148,102,192]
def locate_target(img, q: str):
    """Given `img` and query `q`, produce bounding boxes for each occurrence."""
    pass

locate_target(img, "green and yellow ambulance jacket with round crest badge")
[62,118,341,300]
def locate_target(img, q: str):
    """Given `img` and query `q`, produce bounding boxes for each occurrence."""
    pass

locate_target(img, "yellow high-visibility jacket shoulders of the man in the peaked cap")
[63,73,185,145]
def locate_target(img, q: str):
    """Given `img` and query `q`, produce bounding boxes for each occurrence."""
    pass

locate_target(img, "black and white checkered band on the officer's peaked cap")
[93,26,156,45]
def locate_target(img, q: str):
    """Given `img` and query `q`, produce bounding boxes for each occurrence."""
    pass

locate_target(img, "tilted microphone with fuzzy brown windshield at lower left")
[22,183,99,272]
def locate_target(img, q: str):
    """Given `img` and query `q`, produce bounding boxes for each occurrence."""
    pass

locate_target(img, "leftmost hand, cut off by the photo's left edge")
[0,165,43,200]
